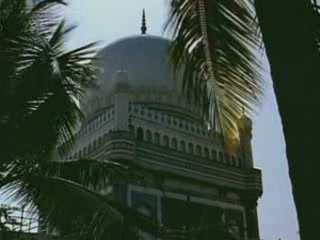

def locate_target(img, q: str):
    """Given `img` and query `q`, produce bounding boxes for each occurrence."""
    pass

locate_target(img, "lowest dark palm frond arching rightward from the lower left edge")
[3,175,157,239]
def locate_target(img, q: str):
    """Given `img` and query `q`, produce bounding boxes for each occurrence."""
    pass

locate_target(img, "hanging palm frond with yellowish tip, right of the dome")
[166,0,263,141]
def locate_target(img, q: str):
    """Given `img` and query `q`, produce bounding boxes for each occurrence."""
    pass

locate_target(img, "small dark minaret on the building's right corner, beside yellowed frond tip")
[238,111,254,168]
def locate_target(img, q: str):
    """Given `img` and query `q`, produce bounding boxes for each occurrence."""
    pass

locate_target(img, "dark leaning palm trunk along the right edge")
[255,0,320,240]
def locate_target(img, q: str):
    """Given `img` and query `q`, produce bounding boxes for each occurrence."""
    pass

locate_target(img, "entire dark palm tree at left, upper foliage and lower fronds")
[0,0,158,239]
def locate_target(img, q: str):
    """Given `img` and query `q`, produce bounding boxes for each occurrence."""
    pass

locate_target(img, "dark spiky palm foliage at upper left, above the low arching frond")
[0,0,96,169]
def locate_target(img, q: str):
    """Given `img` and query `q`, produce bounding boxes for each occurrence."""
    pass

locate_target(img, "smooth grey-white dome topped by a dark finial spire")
[98,35,176,92]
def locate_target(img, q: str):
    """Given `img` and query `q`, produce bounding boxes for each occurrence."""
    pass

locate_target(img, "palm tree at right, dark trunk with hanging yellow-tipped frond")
[168,0,320,239]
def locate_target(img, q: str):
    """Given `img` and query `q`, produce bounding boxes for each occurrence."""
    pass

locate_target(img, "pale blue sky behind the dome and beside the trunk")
[1,0,299,240]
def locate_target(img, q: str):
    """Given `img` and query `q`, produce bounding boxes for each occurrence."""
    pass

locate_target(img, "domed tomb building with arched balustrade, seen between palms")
[66,16,262,239]
